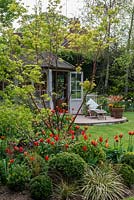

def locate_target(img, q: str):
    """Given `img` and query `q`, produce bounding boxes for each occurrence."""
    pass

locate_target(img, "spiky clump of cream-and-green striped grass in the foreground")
[82,167,128,200]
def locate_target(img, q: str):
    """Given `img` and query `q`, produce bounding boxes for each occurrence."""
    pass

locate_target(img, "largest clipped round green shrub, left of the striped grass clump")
[48,152,86,180]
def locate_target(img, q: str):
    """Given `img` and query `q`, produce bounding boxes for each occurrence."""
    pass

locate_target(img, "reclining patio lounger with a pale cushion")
[86,98,107,119]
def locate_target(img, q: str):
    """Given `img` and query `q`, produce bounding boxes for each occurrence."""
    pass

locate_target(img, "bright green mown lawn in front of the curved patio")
[88,112,134,148]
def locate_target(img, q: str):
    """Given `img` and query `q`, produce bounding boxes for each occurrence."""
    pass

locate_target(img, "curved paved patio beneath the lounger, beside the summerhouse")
[75,115,127,125]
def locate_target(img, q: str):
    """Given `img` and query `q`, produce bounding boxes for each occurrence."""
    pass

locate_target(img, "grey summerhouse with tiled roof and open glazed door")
[37,53,83,113]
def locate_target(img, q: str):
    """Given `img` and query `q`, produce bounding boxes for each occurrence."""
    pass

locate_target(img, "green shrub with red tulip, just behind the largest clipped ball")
[70,141,106,165]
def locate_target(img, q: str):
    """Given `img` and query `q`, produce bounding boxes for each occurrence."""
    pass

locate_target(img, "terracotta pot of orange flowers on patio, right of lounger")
[109,95,124,118]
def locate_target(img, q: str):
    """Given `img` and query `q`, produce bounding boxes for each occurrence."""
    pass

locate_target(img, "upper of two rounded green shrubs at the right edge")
[121,152,134,169]
